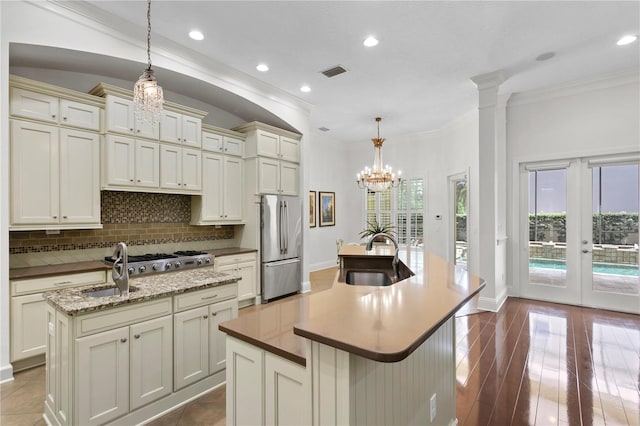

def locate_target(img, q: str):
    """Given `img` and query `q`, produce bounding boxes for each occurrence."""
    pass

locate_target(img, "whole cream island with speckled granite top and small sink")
[44,266,238,426]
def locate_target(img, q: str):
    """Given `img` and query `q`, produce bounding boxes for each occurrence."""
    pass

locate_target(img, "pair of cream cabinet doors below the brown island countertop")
[226,336,312,425]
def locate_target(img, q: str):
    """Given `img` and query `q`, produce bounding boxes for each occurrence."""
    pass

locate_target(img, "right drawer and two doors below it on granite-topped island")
[174,285,238,390]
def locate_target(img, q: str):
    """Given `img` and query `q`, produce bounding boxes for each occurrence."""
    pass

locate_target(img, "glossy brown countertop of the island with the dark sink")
[220,246,485,365]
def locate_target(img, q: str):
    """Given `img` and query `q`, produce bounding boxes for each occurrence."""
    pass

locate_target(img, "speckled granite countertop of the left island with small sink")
[43,266,238,316]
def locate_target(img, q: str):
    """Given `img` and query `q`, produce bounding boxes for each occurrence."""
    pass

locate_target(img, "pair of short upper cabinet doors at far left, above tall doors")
[10,87,100,131]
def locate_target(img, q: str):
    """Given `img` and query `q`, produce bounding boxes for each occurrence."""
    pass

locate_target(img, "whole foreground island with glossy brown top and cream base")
[220,245,484,425]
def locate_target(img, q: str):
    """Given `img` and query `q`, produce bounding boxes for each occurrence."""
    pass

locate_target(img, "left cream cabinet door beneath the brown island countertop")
[226,336,264,426]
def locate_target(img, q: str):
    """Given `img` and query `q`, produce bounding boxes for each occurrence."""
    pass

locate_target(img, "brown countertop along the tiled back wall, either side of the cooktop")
[9,247,257,280]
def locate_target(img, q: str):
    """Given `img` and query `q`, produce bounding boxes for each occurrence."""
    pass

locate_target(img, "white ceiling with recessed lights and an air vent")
[11,0,640,142]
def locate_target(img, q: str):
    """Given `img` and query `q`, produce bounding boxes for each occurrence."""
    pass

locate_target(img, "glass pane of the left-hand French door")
[529,169,567,287]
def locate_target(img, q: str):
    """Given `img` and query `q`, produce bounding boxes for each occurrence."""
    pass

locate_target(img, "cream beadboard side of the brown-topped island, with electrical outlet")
[308,318,456,425]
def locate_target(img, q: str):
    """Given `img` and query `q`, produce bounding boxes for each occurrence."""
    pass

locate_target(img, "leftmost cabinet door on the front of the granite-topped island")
[76,327,129,425]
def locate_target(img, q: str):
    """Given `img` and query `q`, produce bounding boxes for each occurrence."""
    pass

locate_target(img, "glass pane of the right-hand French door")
[591,164,639,295]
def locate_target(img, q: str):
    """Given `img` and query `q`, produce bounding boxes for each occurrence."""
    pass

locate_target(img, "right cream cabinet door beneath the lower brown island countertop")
[264,352,312,425]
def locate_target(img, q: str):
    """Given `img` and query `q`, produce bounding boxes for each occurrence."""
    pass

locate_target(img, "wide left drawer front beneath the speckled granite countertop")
[75,297,171,337]
